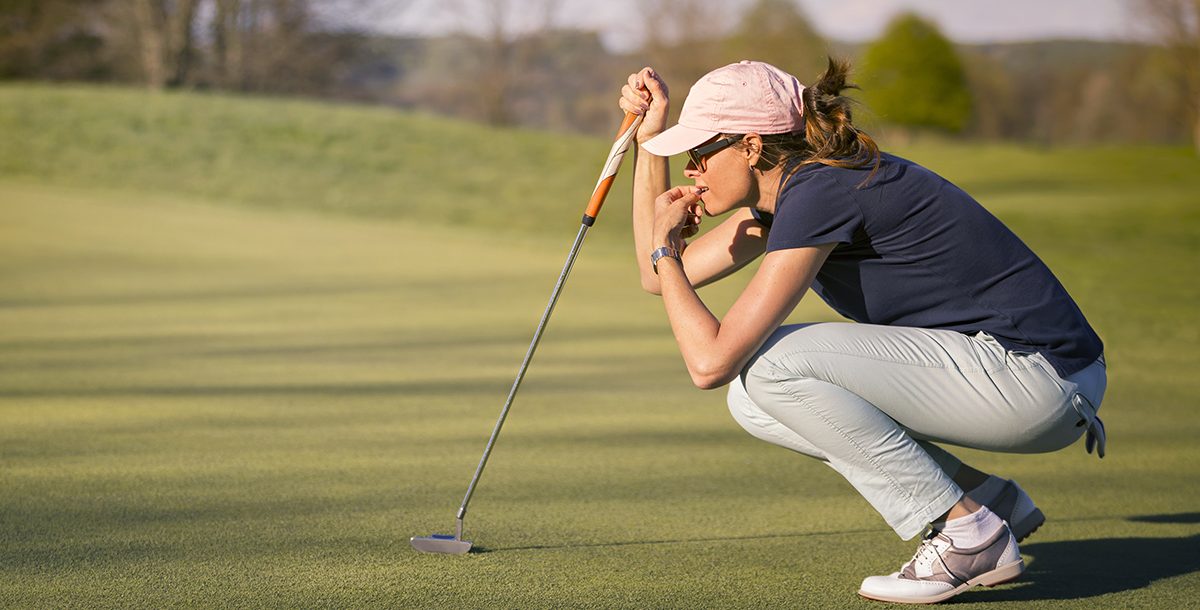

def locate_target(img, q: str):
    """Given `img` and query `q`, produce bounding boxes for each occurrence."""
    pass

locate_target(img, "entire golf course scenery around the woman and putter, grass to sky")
[0,0,1200,610]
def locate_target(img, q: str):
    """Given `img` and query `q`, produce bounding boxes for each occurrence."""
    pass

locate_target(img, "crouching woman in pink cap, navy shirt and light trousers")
[620,60,1105,603]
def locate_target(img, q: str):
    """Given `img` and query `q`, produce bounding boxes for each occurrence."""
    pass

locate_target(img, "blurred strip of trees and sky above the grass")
[0,0,1200,150]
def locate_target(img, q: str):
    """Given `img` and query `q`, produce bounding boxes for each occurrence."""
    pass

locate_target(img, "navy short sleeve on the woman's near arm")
[767,172,863,252]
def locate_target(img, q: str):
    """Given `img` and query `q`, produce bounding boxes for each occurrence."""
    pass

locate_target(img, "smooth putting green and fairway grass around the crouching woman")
[0,84,1200,609]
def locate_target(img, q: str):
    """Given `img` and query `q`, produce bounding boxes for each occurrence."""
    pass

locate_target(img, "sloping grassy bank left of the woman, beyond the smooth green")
[0,85,620,236]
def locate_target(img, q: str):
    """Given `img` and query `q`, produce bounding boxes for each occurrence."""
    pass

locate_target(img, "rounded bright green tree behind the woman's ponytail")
[859,13,972,133]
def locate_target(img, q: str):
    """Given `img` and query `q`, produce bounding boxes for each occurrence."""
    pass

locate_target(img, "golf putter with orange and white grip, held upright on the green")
[412,113,642,555]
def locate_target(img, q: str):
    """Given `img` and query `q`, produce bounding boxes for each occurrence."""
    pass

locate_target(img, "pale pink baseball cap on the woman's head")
[642,60,804,157]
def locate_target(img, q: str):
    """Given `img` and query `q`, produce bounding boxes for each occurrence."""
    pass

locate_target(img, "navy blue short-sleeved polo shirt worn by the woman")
[763,154,1103,377]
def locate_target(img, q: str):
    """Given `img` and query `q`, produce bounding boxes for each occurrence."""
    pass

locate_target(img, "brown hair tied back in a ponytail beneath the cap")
[738,58,880,187]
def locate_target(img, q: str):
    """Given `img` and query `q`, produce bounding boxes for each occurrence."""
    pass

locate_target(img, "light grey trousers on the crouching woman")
[728,323,1106,539]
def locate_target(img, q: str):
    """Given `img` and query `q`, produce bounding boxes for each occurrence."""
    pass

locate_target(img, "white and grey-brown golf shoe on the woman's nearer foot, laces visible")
[858,525,1025,604]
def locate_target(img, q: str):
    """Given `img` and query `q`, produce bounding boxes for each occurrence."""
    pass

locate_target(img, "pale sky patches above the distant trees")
[376,0,1135,50]
